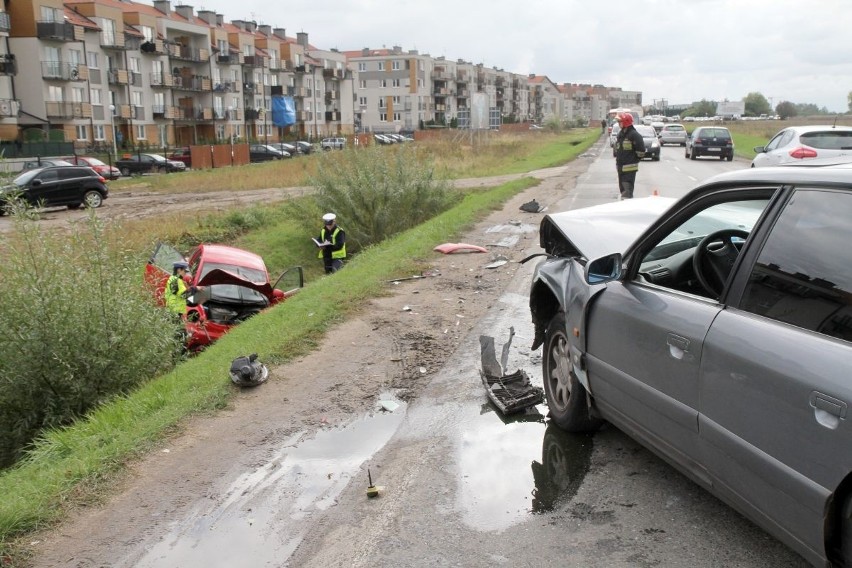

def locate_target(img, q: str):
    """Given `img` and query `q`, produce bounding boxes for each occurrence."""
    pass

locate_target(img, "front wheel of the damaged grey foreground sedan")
[542,311,602,432]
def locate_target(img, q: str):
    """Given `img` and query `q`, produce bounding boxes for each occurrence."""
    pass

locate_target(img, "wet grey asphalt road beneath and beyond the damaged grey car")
[287,147,803,567]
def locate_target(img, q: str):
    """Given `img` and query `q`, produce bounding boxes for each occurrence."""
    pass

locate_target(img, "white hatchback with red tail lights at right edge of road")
[751,125,852,168]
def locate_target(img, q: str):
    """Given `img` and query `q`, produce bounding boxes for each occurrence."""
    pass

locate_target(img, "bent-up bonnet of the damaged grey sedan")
[539,196,677,260]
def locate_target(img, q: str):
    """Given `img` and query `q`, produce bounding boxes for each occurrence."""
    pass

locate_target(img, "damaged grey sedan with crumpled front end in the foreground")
[530,164,852,566]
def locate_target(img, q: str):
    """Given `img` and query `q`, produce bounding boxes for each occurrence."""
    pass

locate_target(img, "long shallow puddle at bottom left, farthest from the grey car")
[134,395,407,568]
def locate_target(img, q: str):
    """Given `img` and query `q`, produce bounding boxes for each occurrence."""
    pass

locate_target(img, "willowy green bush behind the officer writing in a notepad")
[294,145,460,249]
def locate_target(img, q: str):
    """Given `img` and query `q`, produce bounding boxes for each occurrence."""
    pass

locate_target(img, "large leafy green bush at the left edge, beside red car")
[0,202,179,467]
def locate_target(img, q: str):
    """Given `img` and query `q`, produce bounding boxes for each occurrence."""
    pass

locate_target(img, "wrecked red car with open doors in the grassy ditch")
[145,243,304,351]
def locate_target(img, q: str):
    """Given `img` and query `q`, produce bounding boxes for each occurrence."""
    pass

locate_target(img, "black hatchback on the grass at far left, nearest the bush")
[0,164,109,215]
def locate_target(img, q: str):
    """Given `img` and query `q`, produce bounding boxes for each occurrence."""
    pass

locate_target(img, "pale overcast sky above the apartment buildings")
[193,0,852,112]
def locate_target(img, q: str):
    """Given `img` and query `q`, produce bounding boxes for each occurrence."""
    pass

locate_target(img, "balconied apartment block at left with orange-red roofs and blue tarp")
[0,0,353,153]
